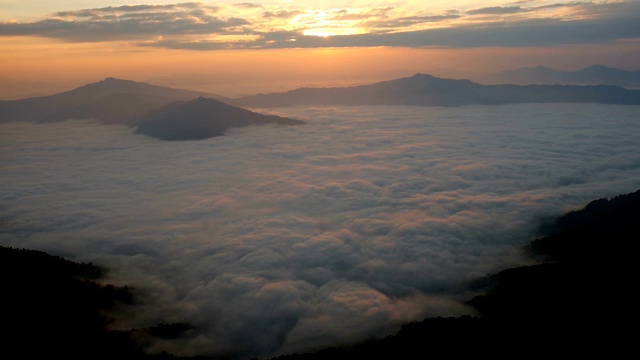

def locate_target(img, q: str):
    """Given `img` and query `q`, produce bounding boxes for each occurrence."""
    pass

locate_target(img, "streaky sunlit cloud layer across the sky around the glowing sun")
[0,1,640,51]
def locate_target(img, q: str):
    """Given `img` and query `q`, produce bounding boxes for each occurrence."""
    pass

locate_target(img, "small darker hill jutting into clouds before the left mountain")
[136,97,304,140]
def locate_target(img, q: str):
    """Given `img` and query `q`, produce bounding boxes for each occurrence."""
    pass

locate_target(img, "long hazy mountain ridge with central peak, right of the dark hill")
[230,74,640,108]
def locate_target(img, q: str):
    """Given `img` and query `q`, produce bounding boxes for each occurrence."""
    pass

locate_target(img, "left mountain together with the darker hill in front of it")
[0,78,304,140]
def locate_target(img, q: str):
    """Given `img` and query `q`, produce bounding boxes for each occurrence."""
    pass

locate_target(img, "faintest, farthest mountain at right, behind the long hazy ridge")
[479,65,640,89]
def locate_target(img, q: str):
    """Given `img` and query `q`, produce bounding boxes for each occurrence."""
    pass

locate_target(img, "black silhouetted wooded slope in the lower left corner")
[0,246,205,360]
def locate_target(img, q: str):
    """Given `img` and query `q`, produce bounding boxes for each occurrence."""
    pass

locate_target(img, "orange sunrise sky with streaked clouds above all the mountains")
[0,0,640,99]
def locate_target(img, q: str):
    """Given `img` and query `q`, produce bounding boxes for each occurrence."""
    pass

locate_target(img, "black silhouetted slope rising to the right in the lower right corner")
[266,190,640,360]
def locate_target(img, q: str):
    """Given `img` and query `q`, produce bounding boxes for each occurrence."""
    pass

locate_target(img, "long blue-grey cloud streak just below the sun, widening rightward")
[149,4,640,50]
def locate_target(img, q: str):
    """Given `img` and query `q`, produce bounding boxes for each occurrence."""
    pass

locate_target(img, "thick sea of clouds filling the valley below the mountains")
[0,104,640,359]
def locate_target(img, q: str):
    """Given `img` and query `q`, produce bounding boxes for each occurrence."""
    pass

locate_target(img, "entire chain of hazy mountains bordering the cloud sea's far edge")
[0,74,640,140]
